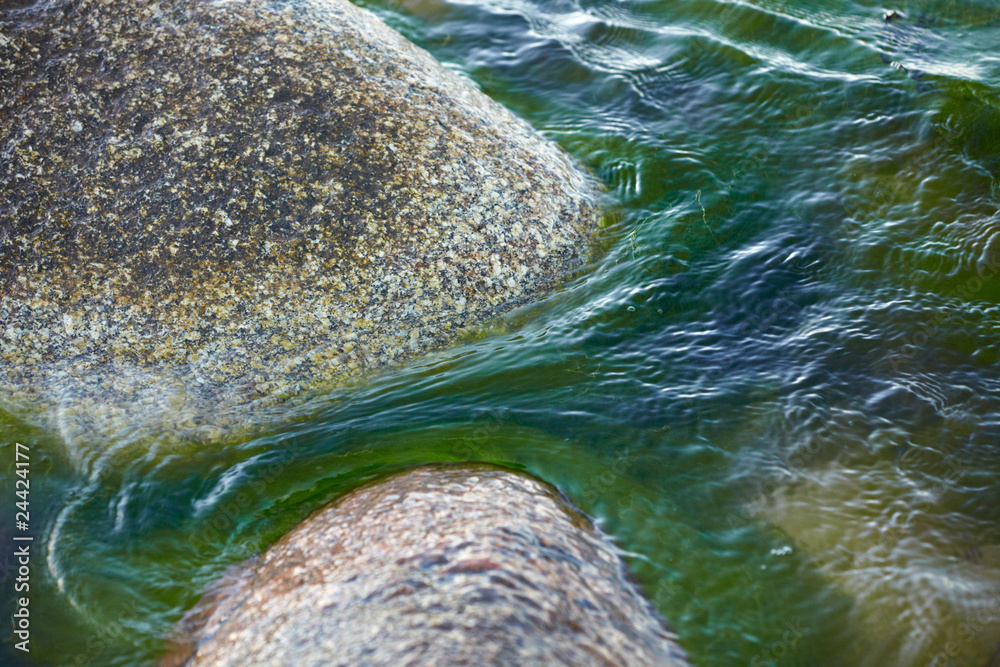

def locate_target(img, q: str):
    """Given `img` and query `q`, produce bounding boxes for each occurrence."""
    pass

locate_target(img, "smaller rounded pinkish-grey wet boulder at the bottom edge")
[161,464,688,667]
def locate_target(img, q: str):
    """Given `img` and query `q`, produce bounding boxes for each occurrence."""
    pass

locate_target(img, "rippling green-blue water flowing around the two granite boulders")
[0,0,1000,667]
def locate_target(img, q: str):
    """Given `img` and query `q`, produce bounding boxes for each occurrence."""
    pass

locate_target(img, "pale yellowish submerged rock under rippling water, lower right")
[763,461,1000,667]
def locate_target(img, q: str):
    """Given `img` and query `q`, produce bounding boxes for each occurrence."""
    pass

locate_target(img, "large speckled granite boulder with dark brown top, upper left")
[0,0,599,446]
